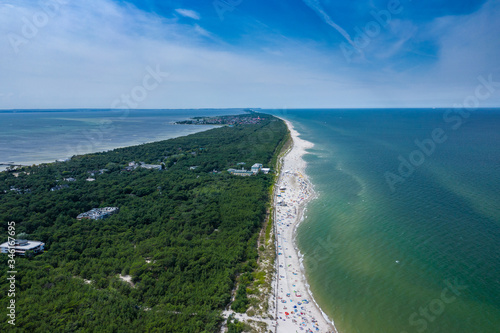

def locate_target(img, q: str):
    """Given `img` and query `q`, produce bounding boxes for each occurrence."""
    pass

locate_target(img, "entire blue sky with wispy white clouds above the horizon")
[0,0,500,109]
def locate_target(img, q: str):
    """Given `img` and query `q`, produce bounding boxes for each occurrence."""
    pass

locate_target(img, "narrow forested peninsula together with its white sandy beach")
[0,113,336,333]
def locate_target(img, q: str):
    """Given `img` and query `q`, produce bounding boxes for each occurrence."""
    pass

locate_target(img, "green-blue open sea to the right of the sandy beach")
[269,110,500,333]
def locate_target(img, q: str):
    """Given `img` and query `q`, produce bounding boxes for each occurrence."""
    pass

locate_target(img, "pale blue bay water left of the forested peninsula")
[0,109,242,170]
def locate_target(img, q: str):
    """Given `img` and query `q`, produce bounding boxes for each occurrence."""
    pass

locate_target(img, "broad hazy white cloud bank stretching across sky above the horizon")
[0,0,500,108]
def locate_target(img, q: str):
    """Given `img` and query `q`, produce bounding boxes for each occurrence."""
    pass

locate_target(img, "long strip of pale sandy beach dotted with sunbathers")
[273,118,338,333]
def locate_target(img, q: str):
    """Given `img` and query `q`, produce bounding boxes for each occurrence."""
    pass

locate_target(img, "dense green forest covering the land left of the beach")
[0,114,287,332]
